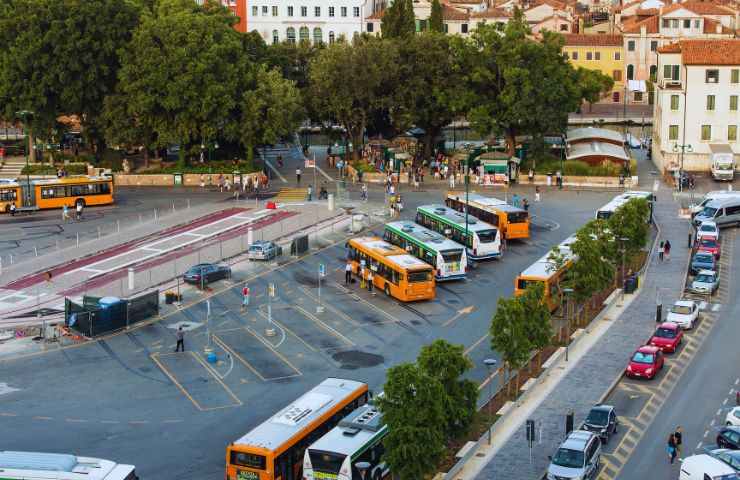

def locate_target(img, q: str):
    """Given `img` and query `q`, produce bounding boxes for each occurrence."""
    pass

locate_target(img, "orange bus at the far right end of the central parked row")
[445,192,529,240]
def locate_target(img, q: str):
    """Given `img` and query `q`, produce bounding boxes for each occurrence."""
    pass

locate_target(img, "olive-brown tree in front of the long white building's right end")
[309,37,399,159]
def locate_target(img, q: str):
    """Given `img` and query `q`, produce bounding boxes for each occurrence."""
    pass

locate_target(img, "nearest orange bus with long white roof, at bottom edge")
[226,378,368,480]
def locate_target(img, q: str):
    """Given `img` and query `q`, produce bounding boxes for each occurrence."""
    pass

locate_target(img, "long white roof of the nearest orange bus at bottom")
[234,378,367,450]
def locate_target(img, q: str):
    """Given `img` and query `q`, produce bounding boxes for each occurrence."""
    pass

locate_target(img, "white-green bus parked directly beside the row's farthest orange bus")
[416,205,501,261]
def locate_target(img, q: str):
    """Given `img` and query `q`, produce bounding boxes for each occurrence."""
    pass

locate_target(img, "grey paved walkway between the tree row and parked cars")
[470,188,689,480]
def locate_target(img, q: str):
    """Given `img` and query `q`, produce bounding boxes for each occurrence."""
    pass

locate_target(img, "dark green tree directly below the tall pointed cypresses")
[398,32,464,158]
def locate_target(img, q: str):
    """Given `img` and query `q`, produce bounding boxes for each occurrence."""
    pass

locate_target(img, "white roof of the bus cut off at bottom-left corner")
[0,451,134,480]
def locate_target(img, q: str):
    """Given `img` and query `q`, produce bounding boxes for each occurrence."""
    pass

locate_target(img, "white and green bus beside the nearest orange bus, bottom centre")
[303,404,390,480]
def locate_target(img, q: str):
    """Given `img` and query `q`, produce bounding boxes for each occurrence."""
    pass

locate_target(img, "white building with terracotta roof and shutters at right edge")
[653,39,740,171]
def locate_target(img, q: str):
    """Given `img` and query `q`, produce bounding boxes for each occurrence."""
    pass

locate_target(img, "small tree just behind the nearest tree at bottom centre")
[417,339,478,437]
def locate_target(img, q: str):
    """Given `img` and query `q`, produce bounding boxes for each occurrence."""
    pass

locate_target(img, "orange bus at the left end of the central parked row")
[347,237,435,302]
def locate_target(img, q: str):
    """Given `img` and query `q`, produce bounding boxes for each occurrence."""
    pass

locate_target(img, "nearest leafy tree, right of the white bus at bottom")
[377,363,446,480]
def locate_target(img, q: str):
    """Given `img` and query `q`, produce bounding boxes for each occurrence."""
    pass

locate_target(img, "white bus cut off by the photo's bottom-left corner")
[0,451,139,480]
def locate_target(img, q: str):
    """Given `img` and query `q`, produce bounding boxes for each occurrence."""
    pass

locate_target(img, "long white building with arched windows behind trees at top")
[247,0,378,44]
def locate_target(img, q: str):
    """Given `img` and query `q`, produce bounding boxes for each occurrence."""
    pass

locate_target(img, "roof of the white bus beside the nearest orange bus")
[308,404,388,455]
